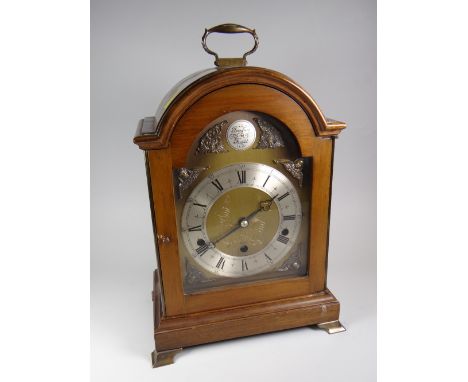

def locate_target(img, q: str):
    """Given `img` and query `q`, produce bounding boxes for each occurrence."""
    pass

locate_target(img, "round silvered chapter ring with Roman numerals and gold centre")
[182,163,302,277]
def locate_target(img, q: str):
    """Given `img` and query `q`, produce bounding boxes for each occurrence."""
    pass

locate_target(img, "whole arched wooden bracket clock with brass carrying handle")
[134,24,346,367]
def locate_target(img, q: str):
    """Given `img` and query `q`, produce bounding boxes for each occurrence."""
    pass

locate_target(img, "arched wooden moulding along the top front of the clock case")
[133,67,346,150]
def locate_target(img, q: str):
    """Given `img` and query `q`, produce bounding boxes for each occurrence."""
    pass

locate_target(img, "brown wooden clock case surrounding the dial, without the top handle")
[134,67,346,367]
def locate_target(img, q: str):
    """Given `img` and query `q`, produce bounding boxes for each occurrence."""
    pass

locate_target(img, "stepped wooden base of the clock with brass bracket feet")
[152,271,345,367]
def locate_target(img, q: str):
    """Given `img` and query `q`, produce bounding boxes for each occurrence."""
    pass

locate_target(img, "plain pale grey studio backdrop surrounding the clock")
[91,0,376,382]
